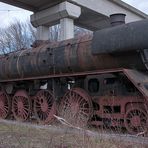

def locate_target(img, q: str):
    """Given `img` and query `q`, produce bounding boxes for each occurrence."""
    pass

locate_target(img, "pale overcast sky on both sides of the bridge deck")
[0,0,148,27]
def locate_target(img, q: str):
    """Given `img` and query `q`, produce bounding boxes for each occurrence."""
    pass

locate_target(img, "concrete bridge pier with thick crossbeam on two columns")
[31,1,81,40]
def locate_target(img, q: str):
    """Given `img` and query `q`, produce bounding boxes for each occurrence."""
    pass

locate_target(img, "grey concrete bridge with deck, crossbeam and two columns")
[0,0,148,40]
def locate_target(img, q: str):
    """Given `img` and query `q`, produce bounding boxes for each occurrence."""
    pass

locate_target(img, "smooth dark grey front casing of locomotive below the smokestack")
[92,20,148,54]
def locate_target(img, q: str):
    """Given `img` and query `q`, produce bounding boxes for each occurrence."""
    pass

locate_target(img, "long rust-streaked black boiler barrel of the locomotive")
[0,36,146,82]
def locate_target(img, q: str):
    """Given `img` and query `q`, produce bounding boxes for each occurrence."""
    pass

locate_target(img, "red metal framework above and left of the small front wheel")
[93,96,144,119]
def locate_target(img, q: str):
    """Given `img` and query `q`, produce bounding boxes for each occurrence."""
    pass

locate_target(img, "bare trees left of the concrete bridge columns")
[0,21,36,54]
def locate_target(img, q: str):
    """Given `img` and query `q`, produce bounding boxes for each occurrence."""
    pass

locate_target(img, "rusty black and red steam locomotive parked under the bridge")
[0,14,148,134]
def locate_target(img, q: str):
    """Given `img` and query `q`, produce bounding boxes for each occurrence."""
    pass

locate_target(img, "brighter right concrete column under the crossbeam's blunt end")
[60,18,74,41]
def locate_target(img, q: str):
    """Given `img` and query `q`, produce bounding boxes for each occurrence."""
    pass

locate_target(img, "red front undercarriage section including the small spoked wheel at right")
[90,96,148,134]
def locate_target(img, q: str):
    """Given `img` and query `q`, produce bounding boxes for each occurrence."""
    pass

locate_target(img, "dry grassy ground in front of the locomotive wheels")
[0,120,148,148]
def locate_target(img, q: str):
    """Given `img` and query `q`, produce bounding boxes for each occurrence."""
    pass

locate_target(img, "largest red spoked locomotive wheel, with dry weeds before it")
[59,88,92,127]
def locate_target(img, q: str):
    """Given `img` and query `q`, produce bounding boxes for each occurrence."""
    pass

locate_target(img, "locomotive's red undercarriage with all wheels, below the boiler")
[0,69,148,134]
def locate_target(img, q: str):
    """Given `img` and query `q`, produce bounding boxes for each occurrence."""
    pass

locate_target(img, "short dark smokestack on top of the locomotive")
[110,13,126,26]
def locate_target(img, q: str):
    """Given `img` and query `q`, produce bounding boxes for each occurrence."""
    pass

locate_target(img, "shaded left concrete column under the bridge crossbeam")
[37,26,49,41]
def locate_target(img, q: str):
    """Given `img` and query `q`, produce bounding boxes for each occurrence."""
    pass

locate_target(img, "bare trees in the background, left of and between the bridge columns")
[0,21,91,54]
